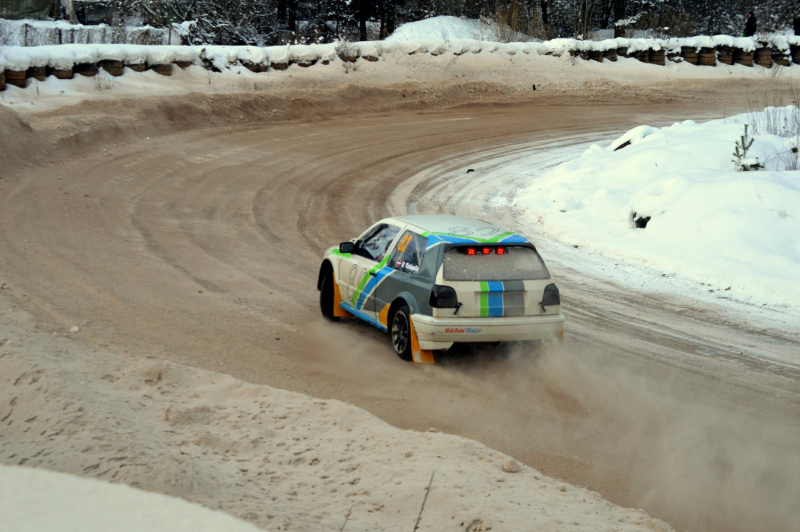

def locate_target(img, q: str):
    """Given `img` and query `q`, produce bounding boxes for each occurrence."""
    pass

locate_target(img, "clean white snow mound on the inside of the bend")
[518,106,800,308]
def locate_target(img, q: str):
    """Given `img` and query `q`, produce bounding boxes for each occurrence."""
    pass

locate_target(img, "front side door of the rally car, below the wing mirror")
[337,222,400,324]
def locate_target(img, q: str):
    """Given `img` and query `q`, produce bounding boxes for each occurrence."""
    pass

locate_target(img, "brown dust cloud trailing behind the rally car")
[442,341,800,531]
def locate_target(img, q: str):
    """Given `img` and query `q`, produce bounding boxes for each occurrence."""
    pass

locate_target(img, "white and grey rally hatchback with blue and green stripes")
[317,215,564,363]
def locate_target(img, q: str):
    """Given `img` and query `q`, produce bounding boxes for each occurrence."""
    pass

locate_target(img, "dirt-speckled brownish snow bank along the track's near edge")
[0,318,671,532]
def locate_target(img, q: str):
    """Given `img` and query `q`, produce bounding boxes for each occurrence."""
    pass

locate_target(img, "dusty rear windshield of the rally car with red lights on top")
[444,246,550,281]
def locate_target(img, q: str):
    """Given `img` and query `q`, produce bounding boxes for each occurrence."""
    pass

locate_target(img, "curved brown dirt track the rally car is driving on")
[0,80,800,530]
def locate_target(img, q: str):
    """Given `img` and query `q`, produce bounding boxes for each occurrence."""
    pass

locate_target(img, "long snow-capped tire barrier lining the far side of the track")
[0,36,800,91]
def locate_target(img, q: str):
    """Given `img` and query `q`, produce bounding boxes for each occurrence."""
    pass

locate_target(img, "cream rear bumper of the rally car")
[411,313,564,349]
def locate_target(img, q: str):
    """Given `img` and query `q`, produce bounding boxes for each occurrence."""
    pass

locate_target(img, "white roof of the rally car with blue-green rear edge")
[387,214,528,243]
